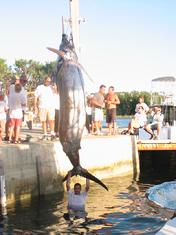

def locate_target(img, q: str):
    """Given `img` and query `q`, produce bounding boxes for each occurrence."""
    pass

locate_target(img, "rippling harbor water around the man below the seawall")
[0,176,168,235]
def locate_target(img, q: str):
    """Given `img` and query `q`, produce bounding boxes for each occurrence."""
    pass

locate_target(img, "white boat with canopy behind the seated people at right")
[139,76,176,140]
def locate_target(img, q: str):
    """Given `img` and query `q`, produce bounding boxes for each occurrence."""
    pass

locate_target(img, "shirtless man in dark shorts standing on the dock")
[105,86,120,135]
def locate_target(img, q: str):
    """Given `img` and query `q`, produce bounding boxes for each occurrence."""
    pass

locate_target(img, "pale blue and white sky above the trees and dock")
[0,0,176,92]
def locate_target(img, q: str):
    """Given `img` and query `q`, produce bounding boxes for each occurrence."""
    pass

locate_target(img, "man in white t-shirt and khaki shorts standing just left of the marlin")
[34,76,55,139]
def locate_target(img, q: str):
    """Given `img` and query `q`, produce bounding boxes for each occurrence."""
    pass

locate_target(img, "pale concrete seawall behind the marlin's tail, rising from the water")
[0,135,139,203]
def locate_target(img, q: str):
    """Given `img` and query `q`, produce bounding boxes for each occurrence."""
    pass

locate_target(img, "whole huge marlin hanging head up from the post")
[48,34,108,190]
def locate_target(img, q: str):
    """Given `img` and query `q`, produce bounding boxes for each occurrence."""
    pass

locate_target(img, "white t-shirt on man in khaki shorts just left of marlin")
[35,84,54,109]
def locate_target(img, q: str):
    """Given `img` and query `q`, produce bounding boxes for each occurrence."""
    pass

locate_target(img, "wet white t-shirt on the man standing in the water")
[67,190,87,211]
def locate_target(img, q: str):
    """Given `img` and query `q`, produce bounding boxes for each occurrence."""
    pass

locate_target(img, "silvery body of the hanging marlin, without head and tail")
[59,62,86,167]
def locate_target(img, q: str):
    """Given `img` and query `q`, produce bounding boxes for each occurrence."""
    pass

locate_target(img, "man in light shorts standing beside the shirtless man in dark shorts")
[92,85,106,135]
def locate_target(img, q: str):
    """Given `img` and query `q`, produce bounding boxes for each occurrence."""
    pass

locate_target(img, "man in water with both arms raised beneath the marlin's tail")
[64,171,90,221]
